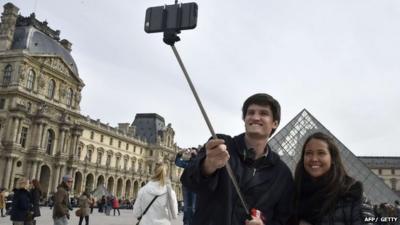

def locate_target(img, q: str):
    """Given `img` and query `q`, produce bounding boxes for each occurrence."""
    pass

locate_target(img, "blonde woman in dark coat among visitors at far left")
[10,178,33,225]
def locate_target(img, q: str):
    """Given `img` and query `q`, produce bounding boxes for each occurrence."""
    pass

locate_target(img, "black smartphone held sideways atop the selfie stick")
[144,2,198,33]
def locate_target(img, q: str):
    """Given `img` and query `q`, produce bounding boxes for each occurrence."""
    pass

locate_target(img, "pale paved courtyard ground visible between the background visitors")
[0,207,182,225]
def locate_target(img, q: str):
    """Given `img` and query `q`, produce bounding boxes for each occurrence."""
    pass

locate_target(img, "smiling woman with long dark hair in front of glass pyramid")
[291,132,374,225]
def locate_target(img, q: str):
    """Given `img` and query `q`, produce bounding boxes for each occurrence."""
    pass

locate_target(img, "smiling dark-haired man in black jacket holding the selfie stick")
[181,94,293,225]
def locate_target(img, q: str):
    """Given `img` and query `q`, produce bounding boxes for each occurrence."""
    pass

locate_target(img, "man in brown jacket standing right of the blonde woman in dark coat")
[53,175,73,225]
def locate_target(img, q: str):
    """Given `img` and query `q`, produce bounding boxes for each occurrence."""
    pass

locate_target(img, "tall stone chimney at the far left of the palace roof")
[0,2,19,51]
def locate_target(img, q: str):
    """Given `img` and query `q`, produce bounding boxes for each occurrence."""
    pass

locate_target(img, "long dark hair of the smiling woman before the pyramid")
[294,132,354,218]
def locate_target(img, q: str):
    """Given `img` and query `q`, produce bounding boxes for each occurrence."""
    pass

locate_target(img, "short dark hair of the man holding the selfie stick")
[242,93,281,136]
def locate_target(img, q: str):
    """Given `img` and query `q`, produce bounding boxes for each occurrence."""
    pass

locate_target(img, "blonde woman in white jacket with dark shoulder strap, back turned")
[133,163,178,225]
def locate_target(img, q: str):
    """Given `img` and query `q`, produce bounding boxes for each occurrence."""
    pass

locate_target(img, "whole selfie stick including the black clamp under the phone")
[163,31,250,215]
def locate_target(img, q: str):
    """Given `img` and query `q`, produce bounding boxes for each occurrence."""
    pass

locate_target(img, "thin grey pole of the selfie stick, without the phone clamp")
[171,44,250,215]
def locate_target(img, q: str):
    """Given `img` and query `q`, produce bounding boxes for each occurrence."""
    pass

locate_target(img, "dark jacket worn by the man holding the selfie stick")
[181,134,293,225]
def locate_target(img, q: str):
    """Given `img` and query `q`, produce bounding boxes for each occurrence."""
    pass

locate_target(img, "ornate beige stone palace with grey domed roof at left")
[0,3,182,199]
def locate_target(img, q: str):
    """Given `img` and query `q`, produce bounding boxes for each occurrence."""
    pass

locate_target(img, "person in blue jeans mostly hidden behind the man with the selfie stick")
[175,148,197,225]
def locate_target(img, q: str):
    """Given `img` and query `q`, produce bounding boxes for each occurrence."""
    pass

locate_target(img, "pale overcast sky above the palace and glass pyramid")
[7,0,400,156]
